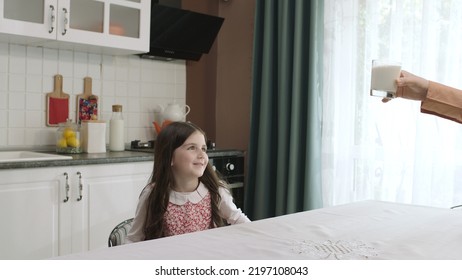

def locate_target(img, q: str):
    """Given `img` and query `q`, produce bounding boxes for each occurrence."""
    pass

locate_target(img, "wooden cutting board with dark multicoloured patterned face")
[77,77,98,124]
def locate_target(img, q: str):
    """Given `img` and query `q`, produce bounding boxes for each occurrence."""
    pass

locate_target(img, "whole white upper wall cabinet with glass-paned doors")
[0,0,151,55]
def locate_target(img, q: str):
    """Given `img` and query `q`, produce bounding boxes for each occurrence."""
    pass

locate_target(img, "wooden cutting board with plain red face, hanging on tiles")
[46,74,69,126]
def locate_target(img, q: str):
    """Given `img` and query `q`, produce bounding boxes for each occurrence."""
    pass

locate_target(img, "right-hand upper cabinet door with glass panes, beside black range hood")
[57,0,150,53]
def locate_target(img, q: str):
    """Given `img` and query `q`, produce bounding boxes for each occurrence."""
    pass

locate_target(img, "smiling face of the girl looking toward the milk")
[171,131,209,184]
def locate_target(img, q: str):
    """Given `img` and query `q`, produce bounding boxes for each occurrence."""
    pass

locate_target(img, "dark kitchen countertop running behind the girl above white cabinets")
[0,150,244,170]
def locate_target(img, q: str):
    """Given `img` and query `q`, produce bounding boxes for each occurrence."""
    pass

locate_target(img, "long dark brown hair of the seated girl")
[144,122,225,240]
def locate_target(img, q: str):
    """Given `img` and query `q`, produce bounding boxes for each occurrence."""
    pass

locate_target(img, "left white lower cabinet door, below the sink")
[0,168,63,259]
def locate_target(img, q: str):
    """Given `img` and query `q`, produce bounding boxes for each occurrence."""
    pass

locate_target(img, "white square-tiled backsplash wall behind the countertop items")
[0,43,186,149]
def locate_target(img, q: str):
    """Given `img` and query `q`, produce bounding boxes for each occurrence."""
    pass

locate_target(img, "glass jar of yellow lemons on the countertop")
[56,120,83,154]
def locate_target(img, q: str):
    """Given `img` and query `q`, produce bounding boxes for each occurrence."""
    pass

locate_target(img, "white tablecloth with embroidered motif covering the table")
[57,201,462,260]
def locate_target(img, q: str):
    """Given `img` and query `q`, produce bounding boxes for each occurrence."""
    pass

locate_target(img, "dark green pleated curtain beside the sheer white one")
[245,0,323,220]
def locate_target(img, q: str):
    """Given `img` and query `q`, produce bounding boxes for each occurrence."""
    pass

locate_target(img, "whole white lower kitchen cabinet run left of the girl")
[0,162,152,259]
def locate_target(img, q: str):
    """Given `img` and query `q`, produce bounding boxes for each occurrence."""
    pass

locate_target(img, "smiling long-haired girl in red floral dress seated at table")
[126,122,250,243]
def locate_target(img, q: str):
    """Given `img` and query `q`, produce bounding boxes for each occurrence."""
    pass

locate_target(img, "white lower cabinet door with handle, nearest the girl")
[59,162,153,255]
